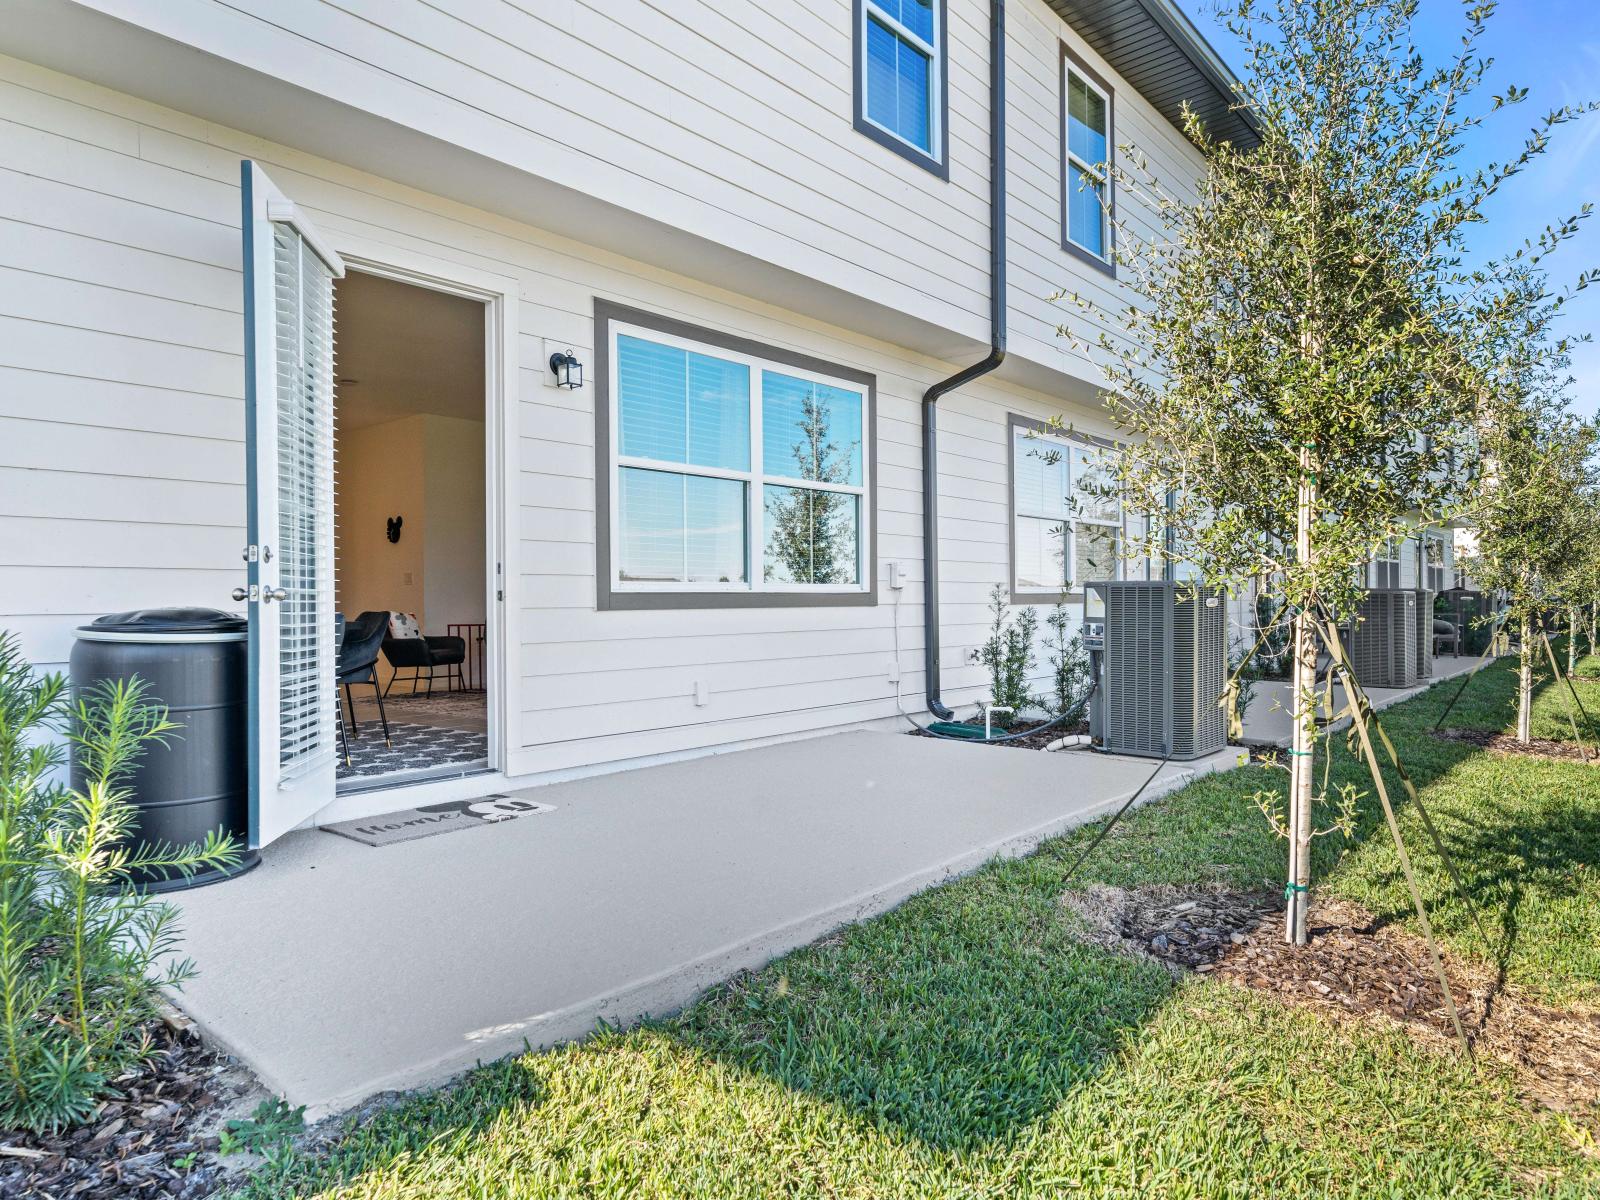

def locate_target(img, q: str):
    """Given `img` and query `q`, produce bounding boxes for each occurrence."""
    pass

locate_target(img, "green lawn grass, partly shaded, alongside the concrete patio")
[232,664,1600,1200]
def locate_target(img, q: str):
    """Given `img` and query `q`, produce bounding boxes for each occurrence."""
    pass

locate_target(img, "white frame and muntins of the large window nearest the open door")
[606,320,872,595]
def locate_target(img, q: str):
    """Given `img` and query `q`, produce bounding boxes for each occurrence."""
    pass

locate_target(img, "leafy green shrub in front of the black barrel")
[0,635,238,1131]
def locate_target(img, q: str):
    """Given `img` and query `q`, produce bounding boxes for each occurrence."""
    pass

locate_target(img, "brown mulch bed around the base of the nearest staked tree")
[1061,885,1600,1120]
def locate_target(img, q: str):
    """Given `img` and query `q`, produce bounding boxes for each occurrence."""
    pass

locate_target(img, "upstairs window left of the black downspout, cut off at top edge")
[856,0,949,178]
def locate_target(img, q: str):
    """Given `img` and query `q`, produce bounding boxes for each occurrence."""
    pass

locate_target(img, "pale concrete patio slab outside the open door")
[178,733,1238,1115]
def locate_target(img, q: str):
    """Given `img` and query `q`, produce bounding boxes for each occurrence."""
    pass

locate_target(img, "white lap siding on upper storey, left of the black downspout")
[78,0,989,336]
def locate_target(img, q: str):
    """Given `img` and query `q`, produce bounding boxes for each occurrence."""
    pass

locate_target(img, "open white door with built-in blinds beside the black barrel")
[235,158,344,846]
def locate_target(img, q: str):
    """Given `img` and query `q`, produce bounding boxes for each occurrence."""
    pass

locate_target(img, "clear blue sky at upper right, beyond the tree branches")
[1178,0,1600,416]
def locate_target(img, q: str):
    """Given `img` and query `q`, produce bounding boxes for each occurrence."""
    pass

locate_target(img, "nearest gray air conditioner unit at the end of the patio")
[1085,581,1227,762]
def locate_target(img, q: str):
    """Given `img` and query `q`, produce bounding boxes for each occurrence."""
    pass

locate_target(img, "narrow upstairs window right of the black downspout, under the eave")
[1061,46,1112,269]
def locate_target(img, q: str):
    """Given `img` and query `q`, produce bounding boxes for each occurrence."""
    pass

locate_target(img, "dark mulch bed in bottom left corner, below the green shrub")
[0,1024,251,1200]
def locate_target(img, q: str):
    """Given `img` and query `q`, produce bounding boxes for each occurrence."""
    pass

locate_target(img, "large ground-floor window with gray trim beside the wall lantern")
[595,302,875,608]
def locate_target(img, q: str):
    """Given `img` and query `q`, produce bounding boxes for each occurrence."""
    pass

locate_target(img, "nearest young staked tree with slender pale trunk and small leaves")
[1061,0,1581,942]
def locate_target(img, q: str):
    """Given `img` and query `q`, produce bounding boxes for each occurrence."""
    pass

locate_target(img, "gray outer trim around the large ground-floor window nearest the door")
[594,296,878,611]
